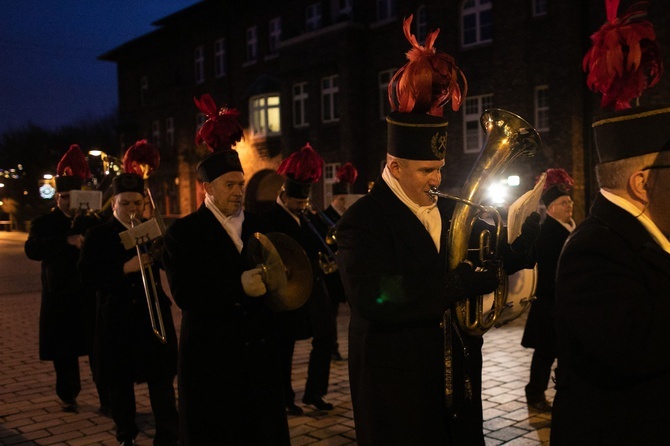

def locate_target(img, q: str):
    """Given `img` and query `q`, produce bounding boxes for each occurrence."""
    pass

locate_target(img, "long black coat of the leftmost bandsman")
[24,208,95,361]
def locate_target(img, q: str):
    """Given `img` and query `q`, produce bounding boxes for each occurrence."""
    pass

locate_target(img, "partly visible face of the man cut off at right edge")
[646,152,670,237]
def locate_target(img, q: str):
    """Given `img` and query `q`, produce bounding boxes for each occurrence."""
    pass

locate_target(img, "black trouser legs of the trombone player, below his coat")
[109,377,179,446]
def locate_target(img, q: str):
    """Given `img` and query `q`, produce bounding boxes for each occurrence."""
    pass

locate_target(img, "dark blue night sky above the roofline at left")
[0,0,199,133]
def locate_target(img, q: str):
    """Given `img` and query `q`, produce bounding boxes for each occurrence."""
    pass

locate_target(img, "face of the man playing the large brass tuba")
[389,159,444,206]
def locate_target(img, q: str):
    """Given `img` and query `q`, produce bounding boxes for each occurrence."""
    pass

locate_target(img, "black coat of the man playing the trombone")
[79,217,177,382]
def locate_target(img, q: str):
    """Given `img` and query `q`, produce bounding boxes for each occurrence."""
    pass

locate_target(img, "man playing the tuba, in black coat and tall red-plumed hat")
[337,16,539,446]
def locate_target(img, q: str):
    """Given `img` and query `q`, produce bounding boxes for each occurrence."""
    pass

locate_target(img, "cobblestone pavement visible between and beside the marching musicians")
[0,232,554,446]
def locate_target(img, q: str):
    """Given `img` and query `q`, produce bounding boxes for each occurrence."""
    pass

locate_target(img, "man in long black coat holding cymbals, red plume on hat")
[163,95,290,446]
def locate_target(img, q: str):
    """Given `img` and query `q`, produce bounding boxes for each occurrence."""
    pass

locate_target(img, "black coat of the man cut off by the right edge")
[551,195,670,446]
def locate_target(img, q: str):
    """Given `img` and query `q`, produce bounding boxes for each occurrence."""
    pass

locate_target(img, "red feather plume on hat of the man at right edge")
[582,0,663,110]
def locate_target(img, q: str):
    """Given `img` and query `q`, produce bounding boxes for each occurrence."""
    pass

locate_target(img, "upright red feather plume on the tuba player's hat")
[388,15,468,116]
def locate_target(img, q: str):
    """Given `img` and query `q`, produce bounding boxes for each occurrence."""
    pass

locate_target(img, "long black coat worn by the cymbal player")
[163,205,289,445]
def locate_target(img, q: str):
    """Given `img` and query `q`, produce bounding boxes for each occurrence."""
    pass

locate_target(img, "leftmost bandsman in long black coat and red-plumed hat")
[24,144,109,414]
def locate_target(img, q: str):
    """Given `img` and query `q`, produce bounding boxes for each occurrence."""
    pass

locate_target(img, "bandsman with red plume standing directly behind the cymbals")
[263,143,337,415]
